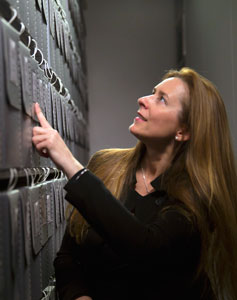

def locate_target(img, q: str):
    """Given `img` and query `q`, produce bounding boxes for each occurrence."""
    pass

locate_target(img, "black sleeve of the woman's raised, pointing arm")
[65,171,198,258]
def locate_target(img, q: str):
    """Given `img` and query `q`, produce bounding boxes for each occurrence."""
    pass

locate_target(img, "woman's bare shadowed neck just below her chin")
[142,145,173,178]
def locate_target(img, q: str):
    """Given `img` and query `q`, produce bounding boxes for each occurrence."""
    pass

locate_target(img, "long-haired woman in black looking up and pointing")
[33,68,237,300]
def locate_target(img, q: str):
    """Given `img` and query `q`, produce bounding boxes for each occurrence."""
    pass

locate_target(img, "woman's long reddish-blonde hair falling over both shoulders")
[69,68,237,300]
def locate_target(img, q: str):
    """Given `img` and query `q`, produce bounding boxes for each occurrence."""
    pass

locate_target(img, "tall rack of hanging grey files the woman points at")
[0,0,88,300]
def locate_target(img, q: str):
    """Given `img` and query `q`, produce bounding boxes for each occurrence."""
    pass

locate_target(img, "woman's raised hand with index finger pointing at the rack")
[32,103,83,178]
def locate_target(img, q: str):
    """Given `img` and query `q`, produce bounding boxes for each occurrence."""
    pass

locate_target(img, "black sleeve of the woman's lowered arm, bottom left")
[54,230,91,300]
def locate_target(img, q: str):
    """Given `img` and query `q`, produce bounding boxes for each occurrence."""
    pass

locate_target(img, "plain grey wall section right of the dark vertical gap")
[186,0,237,154]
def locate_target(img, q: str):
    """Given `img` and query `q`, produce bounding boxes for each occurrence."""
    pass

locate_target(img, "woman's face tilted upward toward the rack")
[129,77,188,143]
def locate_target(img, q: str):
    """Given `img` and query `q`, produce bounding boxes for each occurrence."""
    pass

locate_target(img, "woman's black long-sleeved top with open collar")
[54,171,211,300]
